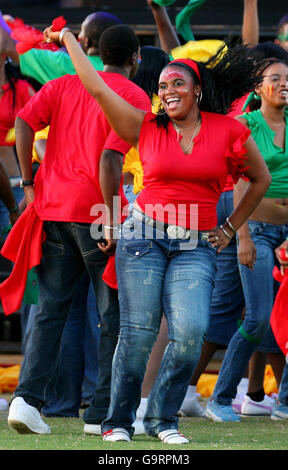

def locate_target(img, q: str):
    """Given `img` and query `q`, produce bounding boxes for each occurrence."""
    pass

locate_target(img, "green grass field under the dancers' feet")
[0,392,288,452]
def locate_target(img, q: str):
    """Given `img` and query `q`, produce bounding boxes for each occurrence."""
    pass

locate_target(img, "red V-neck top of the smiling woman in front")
[137,112,250,230]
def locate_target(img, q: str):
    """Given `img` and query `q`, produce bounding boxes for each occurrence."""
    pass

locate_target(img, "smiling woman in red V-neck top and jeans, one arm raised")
[44,28,270,444]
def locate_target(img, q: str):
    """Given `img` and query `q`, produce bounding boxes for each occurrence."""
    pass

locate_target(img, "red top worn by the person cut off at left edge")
[0,80,34,146]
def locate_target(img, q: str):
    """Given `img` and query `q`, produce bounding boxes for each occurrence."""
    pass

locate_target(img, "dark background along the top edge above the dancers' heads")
[0,0,288,42]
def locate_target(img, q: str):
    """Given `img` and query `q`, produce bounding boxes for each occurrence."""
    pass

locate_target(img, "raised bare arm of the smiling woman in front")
[44,27,145,147]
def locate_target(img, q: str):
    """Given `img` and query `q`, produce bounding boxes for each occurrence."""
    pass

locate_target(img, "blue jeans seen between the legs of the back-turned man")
[20,271,100,417]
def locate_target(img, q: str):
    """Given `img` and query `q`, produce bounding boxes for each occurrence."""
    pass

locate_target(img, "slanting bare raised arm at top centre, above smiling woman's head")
[147,0,181,54]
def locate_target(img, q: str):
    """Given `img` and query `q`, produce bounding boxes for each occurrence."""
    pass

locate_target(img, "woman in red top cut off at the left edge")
[0,54,34,231]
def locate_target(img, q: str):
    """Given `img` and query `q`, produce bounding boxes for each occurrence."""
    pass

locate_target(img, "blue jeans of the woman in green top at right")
[213,221,288,405]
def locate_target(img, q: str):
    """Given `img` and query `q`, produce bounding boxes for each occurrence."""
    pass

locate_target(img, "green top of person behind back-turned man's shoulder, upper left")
[19,46,103,85]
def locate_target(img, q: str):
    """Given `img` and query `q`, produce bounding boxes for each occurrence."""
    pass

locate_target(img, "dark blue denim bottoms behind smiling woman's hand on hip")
[205,191,245,346]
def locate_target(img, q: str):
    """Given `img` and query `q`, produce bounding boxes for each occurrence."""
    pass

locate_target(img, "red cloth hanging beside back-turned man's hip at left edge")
[0,203,45,315]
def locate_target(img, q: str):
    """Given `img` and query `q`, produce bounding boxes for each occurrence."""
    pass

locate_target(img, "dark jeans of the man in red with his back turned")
[15,218,119,423]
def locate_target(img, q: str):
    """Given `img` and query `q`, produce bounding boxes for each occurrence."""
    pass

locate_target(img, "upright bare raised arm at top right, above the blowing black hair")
[242,0,259,47]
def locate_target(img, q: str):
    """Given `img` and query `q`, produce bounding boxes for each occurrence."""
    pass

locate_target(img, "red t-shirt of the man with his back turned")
[18,72,151,223]
